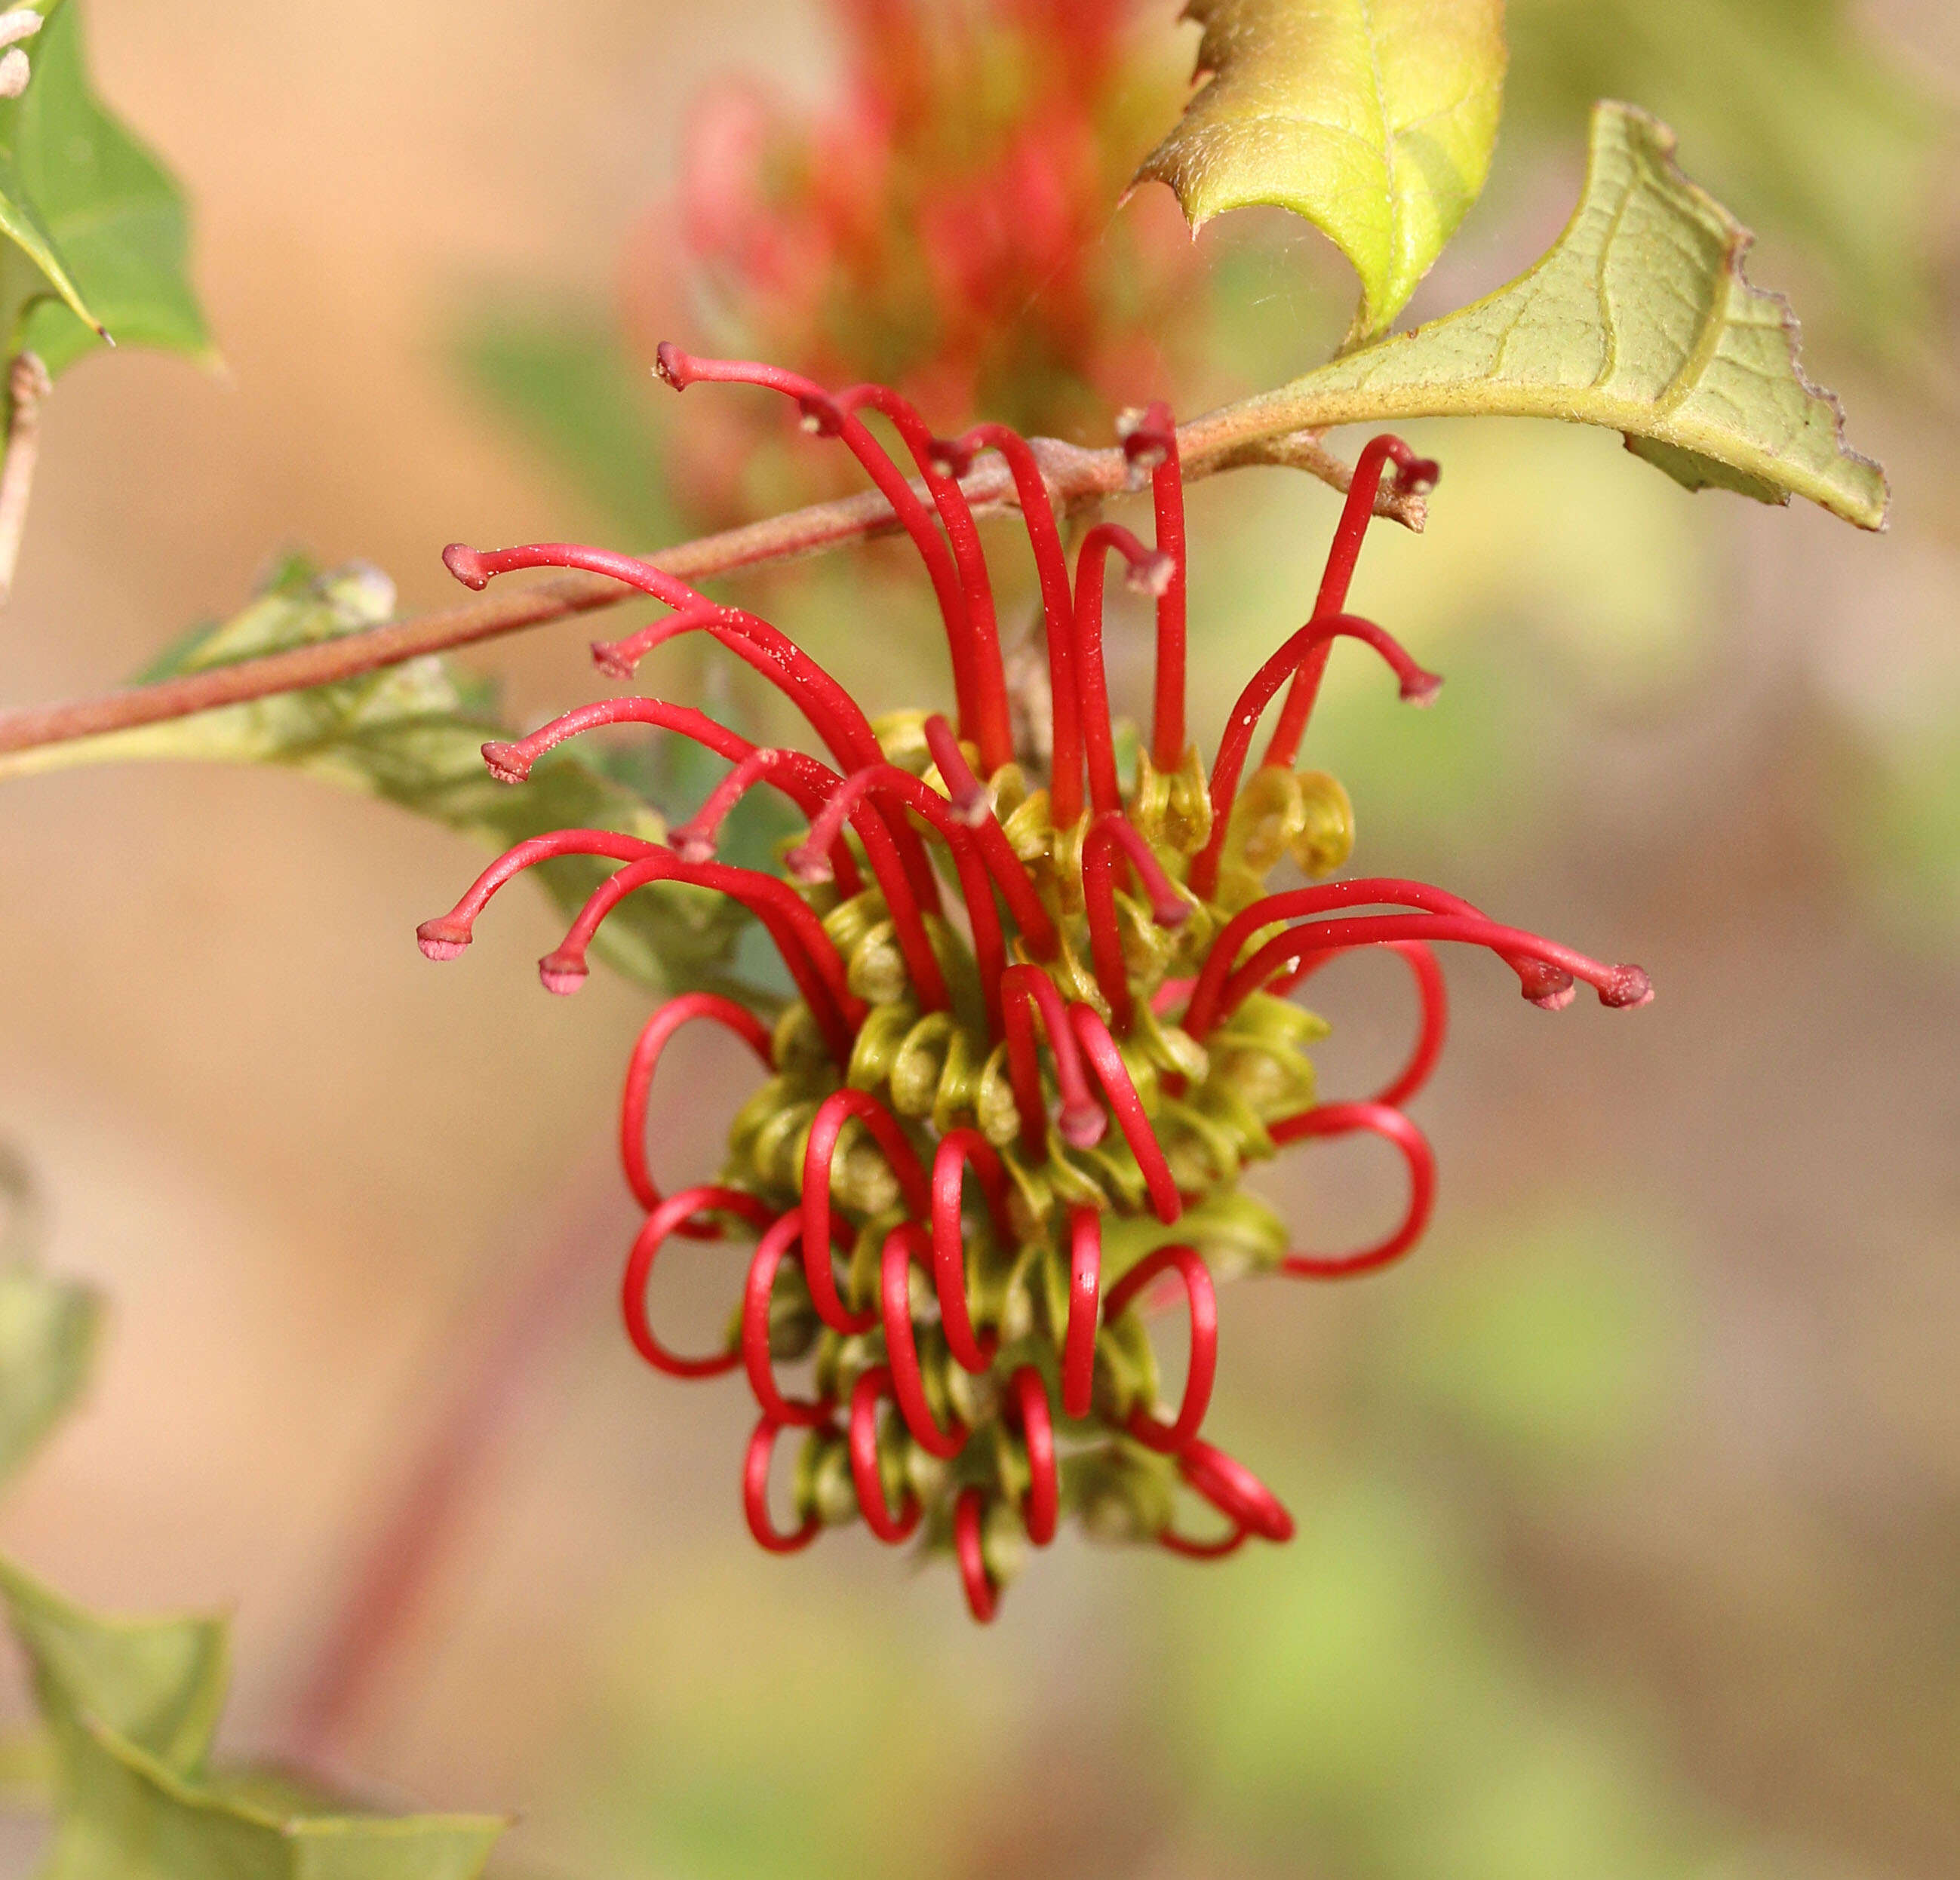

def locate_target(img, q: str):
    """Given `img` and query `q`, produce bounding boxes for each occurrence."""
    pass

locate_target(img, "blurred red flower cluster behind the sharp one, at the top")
[623,0,1184,525]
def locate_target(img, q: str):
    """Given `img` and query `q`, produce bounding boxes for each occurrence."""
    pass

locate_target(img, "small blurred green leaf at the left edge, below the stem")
[0,1143,102,1480]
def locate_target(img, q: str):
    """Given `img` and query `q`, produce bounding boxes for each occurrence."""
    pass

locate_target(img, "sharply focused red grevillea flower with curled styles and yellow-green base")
[419,361,1652,1619]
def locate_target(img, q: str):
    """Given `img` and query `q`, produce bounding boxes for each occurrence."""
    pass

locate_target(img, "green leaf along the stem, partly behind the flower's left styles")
[0,561,778,1006]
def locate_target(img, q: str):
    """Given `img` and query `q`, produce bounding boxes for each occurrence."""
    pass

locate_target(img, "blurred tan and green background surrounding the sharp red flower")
[0,0,1960,1880]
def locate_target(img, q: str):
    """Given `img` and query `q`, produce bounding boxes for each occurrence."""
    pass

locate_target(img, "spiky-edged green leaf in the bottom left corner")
[0,1559,505,1880]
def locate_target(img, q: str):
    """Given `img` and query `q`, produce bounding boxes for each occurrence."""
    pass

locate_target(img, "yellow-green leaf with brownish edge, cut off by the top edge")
[1137,0,1505,339]
